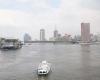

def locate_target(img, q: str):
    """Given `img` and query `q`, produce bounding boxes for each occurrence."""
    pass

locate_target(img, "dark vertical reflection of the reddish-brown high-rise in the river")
[81,44,92,80]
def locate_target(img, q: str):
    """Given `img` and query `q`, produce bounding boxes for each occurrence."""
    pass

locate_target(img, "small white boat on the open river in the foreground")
[38,61,51,75]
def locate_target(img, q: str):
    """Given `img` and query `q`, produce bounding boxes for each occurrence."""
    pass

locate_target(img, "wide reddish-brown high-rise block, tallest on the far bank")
[81,23,90,43]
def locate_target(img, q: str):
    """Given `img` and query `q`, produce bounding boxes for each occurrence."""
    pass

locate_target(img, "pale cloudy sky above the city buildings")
[0,0,100,40]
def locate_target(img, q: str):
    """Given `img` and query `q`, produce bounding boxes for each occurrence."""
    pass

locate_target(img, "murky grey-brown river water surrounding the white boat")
[0,43,100,80]
